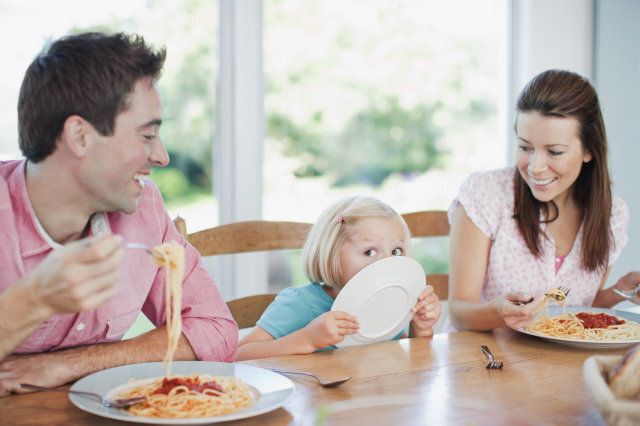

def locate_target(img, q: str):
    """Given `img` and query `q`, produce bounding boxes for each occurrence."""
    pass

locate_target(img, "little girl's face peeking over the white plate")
[340,217,405,285]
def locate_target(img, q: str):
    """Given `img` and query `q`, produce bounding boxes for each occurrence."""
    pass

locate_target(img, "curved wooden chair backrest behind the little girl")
[174,211,449,328]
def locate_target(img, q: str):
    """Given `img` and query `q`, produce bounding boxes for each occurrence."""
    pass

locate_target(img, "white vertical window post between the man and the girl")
[213,0,267,300]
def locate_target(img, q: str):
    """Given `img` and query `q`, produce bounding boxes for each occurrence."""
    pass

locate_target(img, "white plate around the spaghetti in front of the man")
[69,361,294,425]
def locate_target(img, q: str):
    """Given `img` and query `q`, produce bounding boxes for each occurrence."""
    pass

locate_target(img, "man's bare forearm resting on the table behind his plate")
[0,326,196,394]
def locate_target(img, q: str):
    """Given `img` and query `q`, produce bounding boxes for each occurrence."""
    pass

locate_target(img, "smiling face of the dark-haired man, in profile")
[82,77,169,213]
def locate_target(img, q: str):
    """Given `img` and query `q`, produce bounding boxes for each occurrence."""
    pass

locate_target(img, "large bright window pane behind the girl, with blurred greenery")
[263,0,507,290]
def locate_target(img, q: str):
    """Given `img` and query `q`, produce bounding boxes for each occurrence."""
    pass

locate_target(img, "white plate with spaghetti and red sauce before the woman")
[518,306,640,349]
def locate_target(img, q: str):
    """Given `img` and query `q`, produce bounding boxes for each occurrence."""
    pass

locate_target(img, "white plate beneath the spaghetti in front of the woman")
[517,306,640,349]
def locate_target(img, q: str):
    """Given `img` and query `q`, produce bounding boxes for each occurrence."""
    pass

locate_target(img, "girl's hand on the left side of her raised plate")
[305,311,360,351]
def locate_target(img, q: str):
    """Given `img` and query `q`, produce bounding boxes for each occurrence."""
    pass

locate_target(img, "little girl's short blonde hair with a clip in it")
[302,196,411,290]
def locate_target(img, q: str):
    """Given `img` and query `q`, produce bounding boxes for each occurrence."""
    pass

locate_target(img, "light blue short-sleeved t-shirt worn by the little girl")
[256,283,402,351]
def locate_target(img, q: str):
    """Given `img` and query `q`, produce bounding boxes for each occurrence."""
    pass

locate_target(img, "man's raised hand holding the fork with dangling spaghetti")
[27,231,124,314]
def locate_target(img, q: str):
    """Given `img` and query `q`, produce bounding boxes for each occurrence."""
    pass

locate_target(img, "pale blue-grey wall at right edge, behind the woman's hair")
[594,0,640,290]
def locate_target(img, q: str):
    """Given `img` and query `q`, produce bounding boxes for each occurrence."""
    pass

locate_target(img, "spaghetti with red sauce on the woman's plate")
[525,289,640,342]
